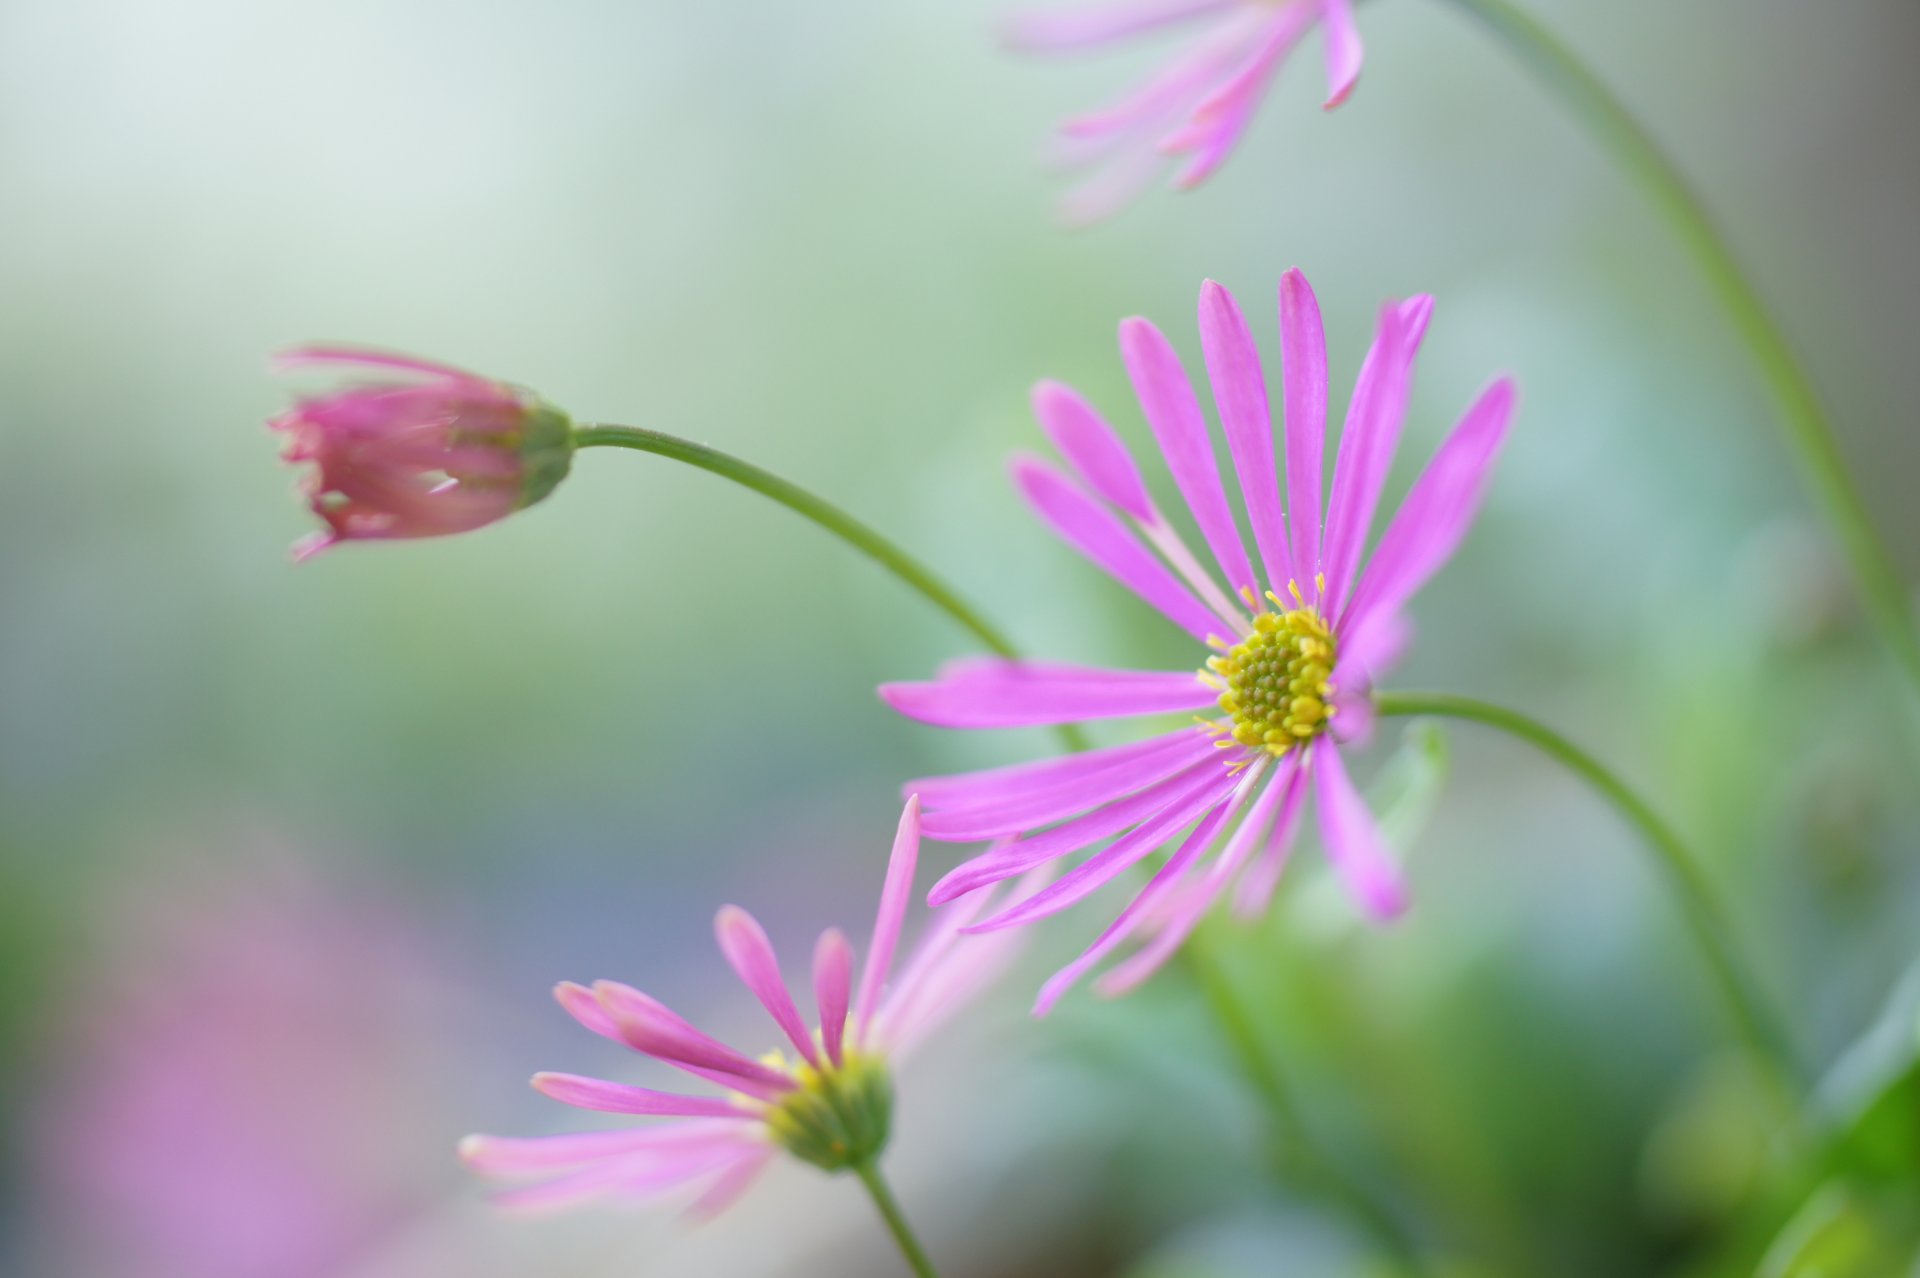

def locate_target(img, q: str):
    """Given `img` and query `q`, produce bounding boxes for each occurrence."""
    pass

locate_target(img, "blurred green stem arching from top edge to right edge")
[1453,0,1920,687]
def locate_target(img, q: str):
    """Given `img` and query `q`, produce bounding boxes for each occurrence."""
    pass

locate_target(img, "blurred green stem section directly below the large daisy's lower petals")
[1181,935,1423,1274]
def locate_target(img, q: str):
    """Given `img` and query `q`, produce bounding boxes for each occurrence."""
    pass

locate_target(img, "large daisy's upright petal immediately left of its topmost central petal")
[1200,280,1294,593]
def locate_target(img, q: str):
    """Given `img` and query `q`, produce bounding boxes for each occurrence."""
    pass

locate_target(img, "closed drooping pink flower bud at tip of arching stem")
[269,345,574,558]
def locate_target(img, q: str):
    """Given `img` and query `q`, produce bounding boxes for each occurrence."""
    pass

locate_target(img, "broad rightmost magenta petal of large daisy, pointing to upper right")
[1342,378,1513,627]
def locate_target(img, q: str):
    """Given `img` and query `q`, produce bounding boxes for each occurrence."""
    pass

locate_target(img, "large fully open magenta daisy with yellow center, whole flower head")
[881,271,1513,1011]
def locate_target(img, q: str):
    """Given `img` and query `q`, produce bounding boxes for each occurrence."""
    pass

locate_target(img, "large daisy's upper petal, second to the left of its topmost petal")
[1119,317,1258,591]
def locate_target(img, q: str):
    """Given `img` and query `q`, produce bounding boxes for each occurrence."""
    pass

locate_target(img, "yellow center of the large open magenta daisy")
[1208,595,1334,754]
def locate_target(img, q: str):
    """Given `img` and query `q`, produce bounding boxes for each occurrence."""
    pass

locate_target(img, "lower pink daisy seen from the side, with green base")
[461,798,1014,1217]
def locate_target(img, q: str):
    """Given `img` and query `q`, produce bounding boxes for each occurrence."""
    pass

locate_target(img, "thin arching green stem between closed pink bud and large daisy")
[574,422,1087,750]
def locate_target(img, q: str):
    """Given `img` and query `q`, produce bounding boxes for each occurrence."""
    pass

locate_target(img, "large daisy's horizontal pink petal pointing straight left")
[879,662,1219,727]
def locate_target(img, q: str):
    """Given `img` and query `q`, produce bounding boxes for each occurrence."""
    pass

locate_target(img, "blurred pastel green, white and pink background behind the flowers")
[0,0,1920,1278]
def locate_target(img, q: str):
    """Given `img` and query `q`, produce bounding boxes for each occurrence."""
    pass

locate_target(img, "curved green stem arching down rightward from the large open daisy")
[1375,693,1807,1088]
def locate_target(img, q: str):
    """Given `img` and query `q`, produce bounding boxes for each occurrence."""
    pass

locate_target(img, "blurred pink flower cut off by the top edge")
[1006,0,1361,223]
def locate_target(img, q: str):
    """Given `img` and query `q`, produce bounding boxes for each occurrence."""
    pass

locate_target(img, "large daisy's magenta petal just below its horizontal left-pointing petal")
[902,727,1210,825]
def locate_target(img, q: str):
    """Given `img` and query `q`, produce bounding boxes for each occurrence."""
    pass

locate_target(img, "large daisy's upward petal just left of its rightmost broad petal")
[1323,305,1417,616]
